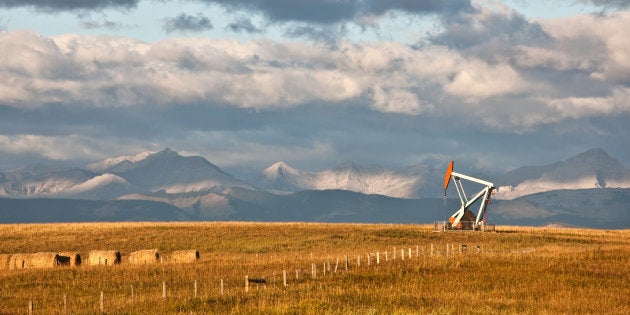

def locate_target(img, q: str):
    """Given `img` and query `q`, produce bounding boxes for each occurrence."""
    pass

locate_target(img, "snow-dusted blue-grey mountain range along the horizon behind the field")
[0,148,630,228]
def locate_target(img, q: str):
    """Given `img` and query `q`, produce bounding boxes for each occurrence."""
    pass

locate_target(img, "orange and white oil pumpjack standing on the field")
[433,161,495,231]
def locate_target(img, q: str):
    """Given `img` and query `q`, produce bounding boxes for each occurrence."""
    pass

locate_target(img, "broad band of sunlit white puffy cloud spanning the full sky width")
[0,4,630,133]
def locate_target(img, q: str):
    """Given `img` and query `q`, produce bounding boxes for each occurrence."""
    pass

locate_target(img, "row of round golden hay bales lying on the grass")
[0,249,199,270]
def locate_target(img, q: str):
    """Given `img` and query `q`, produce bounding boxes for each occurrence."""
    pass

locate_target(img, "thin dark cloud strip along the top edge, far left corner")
[0,0,140,12]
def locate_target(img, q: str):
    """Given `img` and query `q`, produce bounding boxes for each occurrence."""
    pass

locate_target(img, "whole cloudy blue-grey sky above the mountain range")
[0,0,630,174]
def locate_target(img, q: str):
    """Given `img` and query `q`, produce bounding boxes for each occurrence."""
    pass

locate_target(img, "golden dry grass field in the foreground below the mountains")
[0,223,630,314]
